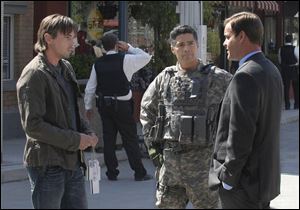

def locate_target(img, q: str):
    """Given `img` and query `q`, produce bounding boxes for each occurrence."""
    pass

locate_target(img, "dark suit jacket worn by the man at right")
[209,53,283,201]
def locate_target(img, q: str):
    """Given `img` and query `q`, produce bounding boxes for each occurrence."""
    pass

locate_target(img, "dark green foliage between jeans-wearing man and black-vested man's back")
[68,55,96,79]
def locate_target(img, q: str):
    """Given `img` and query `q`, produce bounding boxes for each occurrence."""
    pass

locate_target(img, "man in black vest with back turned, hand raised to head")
[84,33,152,181]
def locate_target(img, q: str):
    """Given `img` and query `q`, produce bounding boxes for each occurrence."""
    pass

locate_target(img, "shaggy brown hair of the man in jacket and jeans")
[34,14,78,53]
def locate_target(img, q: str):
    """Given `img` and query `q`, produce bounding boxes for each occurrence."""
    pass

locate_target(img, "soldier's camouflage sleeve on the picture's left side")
[140,71,165,146]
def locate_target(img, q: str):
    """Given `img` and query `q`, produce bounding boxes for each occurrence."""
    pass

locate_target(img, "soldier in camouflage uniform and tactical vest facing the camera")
[141,25,232,209]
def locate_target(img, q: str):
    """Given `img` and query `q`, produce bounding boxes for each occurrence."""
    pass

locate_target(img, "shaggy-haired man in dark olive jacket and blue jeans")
[17,14,98,209]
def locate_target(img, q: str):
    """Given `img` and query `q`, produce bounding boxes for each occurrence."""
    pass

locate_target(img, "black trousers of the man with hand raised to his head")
[99,98,146,177]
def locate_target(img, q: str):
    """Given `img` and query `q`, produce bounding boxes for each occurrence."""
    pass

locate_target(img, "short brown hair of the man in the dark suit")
[224,12,264,45]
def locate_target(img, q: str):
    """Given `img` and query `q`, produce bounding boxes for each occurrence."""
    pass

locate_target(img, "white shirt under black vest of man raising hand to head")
[84,44,152,110]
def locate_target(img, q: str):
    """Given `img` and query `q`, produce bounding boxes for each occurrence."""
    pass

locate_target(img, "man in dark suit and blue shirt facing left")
[209,12,283,209]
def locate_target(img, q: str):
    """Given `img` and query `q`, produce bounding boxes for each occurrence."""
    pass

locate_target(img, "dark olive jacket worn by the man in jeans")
[17,53,92,170]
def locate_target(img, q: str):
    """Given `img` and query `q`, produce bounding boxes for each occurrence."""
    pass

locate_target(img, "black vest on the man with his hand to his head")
[95,53,130,96]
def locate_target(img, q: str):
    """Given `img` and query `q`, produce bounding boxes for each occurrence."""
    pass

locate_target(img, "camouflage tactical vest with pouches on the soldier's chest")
[162,66,212,145]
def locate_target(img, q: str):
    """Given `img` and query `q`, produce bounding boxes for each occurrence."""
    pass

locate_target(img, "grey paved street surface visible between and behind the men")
[1,122,299,209]
